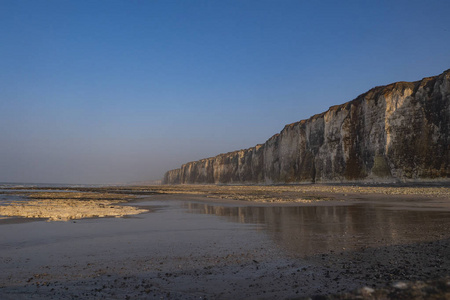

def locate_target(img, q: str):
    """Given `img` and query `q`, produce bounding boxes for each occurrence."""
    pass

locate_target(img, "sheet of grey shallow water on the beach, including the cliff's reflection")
[0,200,450,299]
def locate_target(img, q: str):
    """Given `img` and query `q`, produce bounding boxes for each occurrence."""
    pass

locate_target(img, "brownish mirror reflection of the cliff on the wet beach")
[185,203,450,255]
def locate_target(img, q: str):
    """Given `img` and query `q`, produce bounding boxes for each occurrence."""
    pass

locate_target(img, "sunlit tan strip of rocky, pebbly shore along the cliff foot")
[0,184,450,225]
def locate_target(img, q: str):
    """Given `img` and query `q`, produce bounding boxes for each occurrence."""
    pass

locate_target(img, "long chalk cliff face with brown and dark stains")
[163,70,450,184]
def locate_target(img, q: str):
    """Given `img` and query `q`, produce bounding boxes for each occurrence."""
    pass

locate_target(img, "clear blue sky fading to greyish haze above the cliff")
[0,0,450,183]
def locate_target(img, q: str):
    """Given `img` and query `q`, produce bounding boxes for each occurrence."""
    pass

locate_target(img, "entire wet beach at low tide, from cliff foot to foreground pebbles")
[0,185,450,299]
